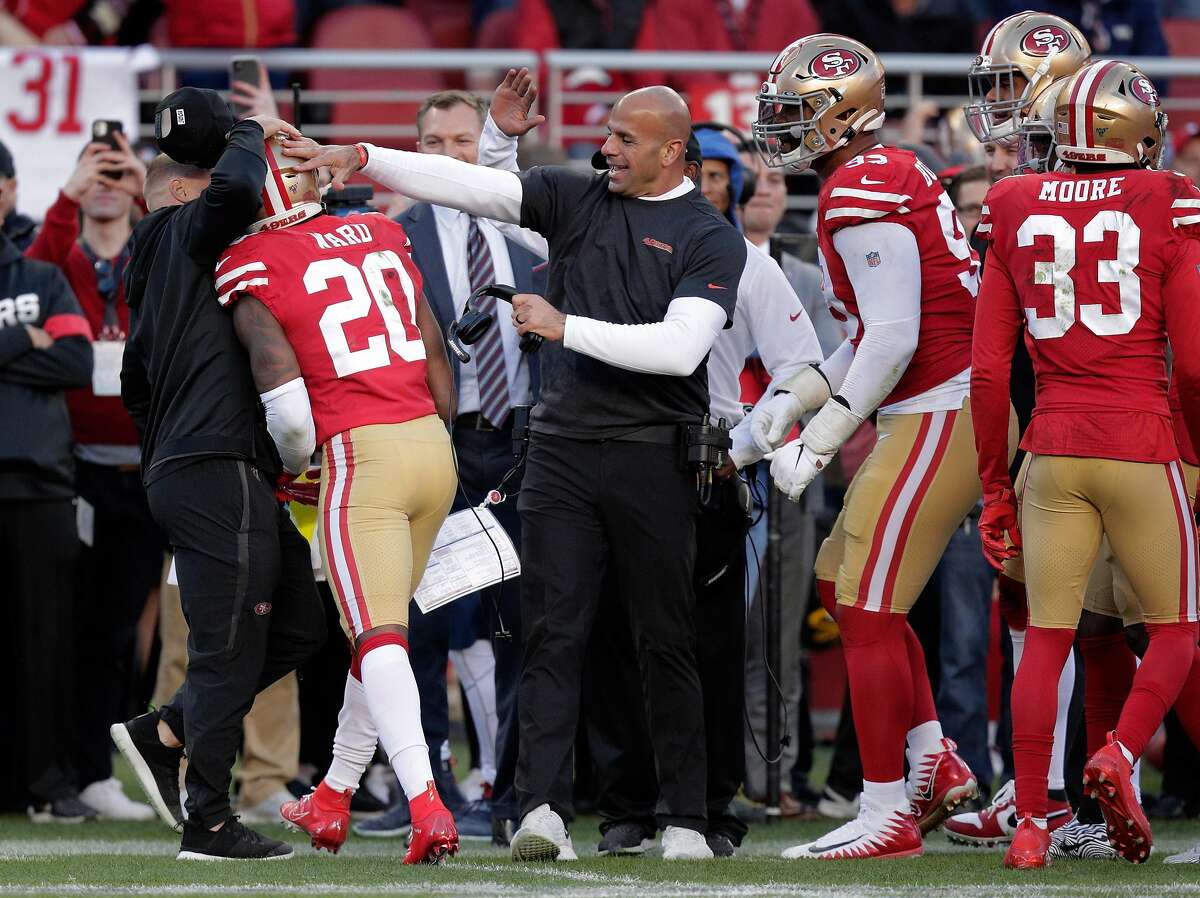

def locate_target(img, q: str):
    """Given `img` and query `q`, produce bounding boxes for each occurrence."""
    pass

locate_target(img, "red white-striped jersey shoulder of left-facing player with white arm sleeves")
[818,151,921,233]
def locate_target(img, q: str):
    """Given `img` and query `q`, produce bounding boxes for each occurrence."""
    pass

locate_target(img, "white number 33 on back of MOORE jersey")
[1016,209,1141,340]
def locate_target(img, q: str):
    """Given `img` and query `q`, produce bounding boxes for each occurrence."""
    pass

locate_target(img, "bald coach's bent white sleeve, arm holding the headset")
[563,297,726,377]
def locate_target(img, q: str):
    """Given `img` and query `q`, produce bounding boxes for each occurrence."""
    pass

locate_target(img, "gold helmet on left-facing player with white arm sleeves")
[754,34,883,170]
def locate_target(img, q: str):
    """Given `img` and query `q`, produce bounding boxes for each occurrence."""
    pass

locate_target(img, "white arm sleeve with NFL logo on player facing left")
[822,222,920,418]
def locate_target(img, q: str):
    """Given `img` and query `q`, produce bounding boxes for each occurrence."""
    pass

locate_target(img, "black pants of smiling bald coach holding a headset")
[516,433,700,832]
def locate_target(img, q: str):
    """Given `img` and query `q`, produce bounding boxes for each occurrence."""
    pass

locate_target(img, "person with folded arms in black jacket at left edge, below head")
[0,233,96,822]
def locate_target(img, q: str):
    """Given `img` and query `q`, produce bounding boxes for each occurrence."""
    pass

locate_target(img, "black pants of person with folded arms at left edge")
[0,497,79,809]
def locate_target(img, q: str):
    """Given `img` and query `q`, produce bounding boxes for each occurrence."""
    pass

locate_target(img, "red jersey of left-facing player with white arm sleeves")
[817,146,979,406]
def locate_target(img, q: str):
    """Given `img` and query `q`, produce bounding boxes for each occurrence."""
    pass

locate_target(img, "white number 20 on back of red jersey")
[304,250,425,377]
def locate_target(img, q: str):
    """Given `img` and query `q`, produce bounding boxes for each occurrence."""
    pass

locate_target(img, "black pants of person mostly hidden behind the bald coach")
[584,480,748,845]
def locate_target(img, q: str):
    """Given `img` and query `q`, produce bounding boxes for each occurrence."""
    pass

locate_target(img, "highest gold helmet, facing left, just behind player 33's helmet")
[964,12,1092,143]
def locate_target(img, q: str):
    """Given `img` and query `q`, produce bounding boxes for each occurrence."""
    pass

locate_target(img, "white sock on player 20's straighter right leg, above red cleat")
[361,643,433,801]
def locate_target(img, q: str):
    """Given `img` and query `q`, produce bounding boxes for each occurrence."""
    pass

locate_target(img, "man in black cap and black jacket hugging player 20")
[112,88,325,860]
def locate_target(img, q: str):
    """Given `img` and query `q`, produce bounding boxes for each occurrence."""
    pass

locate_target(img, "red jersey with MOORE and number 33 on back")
[972,169,1200,494]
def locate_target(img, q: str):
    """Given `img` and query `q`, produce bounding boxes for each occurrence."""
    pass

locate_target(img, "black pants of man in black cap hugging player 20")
[148,459,325,826]
